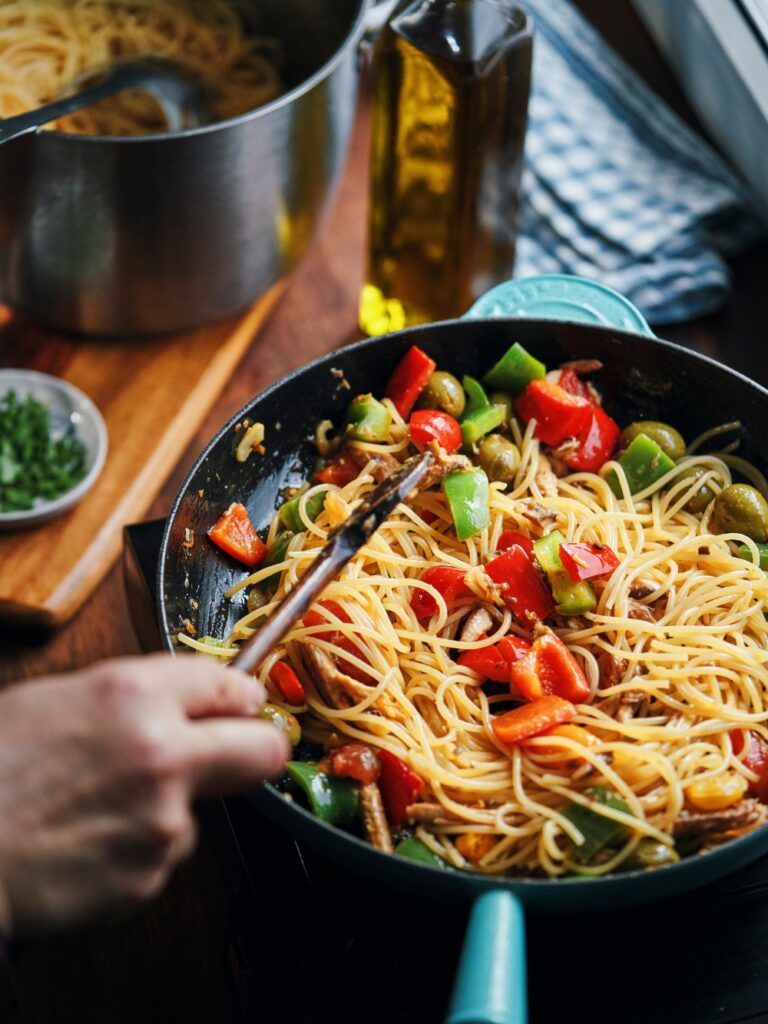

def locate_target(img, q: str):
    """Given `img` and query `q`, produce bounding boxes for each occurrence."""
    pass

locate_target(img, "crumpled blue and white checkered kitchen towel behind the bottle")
[515,0,764,324]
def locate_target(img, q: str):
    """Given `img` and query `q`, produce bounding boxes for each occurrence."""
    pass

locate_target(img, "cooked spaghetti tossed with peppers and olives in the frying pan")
[189,354,768,877]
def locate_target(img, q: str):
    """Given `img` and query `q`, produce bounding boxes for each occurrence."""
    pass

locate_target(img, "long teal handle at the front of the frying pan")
[445,889,527,1024]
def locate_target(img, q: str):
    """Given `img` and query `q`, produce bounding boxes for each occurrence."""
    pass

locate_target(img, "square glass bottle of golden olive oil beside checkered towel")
[359,0,532,334]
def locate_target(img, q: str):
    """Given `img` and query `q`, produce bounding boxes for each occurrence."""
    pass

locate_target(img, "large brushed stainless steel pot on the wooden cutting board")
[0,0,368,334]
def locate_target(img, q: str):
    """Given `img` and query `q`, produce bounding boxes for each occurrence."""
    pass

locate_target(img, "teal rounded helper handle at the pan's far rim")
[464,273,654,338]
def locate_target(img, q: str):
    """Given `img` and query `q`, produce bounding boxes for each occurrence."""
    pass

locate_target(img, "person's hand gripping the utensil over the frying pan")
[0,654,289,935]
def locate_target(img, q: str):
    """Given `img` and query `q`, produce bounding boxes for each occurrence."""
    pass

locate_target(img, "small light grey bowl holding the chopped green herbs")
[0,370,109,530]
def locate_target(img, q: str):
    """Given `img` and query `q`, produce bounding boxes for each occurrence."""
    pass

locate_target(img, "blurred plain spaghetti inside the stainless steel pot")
[0,0,283,135]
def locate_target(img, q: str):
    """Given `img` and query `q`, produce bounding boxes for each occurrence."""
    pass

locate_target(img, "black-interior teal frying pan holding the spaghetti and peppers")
[158,307,768,1024]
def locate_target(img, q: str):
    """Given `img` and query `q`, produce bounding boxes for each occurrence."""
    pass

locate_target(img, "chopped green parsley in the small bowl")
[0,390,87,512]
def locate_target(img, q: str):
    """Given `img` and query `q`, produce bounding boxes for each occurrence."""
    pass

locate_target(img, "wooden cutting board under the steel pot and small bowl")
[0,285,283,630]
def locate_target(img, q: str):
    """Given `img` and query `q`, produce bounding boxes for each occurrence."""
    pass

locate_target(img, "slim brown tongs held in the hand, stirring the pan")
[229,451,435,672]
